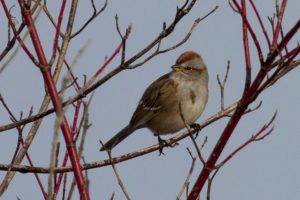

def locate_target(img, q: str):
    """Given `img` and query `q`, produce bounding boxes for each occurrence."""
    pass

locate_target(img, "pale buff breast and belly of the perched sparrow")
[146,78,208,135]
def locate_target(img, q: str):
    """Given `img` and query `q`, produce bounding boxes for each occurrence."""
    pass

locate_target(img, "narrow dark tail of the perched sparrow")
[100,125,135,151]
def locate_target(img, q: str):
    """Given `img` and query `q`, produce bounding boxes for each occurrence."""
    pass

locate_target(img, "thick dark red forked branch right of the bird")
[188,0,300,200]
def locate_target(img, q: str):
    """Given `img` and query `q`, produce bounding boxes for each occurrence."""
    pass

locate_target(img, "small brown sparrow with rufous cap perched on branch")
[100,51,209,151]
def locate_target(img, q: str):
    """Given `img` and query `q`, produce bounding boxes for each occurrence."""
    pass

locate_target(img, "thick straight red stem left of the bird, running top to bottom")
[15,0,89,200]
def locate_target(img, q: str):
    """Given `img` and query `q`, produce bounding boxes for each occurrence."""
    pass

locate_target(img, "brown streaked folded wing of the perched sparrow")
[130,74,177,127]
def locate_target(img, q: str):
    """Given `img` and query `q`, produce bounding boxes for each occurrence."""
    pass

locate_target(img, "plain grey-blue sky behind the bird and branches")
[0,0,300,200]
